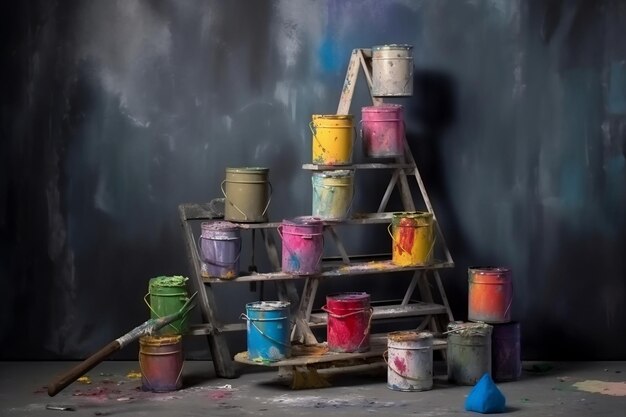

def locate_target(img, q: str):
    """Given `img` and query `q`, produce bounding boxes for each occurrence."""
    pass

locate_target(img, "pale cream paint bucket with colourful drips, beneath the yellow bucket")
[311,169,354,220]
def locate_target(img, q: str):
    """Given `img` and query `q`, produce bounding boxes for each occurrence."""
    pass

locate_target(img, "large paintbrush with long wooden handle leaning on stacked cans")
[48,293,197,397]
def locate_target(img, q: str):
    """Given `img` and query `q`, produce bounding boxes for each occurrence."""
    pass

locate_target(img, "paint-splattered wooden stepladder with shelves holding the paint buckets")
[179,49,454,378]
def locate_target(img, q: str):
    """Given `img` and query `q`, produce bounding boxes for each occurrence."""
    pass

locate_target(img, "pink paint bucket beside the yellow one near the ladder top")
[361,104,404,158]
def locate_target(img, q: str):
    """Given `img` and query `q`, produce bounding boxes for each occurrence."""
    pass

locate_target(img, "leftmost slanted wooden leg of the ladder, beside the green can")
[179,207,238,378]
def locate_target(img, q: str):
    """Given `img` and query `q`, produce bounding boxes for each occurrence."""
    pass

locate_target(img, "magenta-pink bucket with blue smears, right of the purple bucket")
[278,216,324,275]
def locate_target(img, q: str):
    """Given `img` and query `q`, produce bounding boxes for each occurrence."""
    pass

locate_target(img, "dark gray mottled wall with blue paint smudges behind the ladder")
[0,0,626,360]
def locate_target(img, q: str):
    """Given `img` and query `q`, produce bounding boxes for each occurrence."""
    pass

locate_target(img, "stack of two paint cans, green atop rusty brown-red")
[139,276,189,392]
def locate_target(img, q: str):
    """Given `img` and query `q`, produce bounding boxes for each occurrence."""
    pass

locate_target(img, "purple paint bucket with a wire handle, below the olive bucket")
[198,221,241,279]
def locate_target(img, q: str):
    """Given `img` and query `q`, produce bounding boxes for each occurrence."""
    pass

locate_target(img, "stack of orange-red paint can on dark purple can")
[468,267,522,381]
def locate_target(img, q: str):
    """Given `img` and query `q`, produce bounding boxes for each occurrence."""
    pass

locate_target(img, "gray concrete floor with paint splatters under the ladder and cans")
[0,361,626,417]
